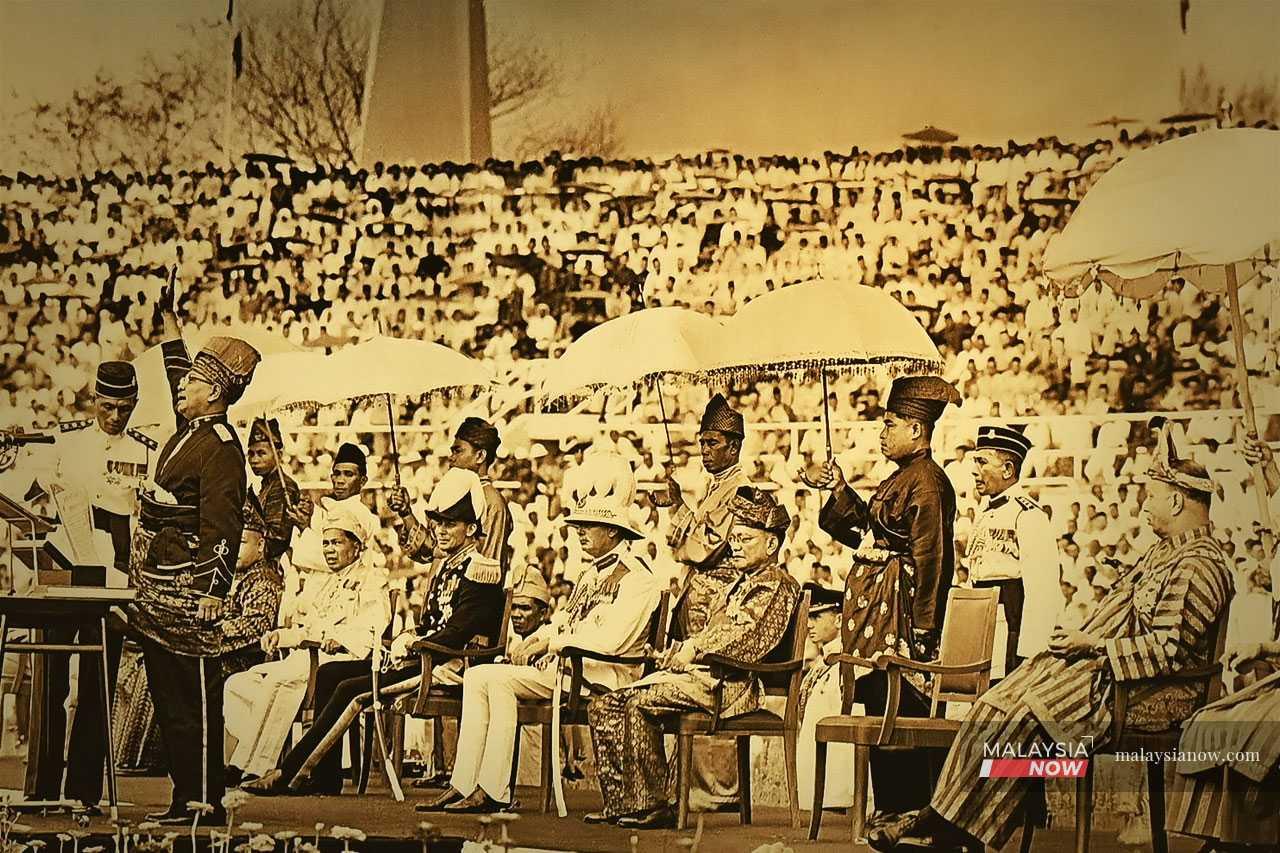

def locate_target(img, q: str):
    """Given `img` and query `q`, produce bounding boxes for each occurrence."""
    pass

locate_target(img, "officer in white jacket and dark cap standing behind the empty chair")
[965,427,1064,675]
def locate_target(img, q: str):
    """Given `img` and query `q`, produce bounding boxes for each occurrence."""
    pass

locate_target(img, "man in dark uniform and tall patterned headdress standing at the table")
[129,337,259,825]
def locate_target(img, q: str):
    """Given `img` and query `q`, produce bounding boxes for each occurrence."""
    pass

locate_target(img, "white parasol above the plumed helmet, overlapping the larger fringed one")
[540,307,727,456]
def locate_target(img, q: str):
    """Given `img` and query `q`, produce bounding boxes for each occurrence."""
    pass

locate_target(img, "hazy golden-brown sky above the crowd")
[0,0,1280,156]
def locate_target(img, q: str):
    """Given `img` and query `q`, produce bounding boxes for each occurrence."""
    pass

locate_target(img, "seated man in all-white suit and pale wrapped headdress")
[223,505,389,776]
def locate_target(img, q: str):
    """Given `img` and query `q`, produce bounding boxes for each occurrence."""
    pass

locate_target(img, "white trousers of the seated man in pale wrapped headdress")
[223,649,351,776]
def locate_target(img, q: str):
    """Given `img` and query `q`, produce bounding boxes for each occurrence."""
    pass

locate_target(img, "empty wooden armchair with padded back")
[809,588,1000,840]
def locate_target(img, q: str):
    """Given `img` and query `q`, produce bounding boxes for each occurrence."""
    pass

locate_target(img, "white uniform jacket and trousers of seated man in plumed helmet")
[451,542,662,803]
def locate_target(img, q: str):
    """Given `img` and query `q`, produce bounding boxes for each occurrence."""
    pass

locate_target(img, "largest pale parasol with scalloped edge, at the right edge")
[1044,129,1280,558]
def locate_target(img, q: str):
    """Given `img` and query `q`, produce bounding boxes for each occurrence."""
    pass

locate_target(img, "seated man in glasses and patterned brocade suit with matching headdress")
[585,485,800,829]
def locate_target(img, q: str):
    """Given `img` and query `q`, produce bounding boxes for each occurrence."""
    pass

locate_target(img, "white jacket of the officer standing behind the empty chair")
[965,483,1065,675]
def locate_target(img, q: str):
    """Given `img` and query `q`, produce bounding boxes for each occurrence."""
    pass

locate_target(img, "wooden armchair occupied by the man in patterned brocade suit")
[663,593,809,830]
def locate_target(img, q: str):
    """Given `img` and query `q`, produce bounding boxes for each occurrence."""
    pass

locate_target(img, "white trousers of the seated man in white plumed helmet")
[451,663,556,803]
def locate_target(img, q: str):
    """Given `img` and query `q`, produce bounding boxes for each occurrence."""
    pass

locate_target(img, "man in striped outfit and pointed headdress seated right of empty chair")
[868,432,1233,850]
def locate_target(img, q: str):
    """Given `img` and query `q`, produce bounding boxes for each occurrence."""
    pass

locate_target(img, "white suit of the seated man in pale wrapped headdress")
[223,553,390,776]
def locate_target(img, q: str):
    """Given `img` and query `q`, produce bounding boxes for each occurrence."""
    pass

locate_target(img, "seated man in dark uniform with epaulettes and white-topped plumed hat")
[244,469,503,794]
